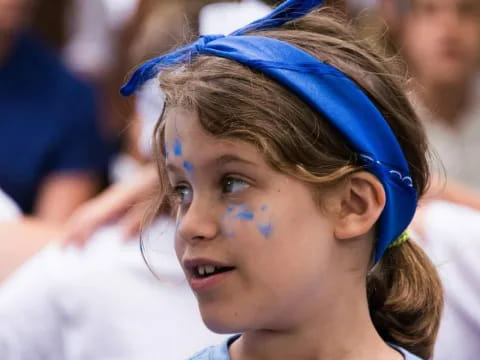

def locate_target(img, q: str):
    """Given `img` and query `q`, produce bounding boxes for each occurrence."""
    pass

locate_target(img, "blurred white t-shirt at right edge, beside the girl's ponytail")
[422,202,480,360]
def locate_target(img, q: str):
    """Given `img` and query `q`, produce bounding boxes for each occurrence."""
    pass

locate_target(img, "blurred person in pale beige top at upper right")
[381,0,480,209]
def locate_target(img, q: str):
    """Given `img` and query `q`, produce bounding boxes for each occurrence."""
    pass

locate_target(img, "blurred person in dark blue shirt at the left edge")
[0,0,108,223]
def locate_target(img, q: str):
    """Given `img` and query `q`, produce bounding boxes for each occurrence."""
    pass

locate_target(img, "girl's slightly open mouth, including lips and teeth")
[183,259,236,292]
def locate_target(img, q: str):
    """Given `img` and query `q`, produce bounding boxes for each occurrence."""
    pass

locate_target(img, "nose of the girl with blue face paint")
[177,196,220,244]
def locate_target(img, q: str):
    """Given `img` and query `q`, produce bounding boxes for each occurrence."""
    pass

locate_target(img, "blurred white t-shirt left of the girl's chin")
[0,219,223,360]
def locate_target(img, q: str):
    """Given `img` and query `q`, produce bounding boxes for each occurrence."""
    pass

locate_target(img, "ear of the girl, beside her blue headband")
[335,171,386,239]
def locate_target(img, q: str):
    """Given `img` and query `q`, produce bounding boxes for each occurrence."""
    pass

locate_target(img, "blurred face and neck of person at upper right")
[401,0,480,127]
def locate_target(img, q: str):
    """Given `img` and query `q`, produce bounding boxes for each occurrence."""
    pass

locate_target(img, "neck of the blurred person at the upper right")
[415,75,473,127]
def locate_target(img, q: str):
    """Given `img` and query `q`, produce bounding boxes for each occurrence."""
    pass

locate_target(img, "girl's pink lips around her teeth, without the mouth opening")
[182,258,234,292]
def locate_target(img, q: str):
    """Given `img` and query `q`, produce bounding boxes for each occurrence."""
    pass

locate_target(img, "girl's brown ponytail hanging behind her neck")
[367,240,443,359]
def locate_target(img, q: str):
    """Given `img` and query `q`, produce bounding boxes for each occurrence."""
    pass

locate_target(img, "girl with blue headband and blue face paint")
[122,0,442,360]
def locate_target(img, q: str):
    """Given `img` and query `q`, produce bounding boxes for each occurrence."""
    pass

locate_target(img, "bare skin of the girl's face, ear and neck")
[165,108,402,360]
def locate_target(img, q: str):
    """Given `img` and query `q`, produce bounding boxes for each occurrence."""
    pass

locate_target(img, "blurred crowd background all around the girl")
[0,0,480,360]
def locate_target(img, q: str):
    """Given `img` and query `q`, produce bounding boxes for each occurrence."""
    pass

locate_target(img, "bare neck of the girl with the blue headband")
[230,289,402,360]
